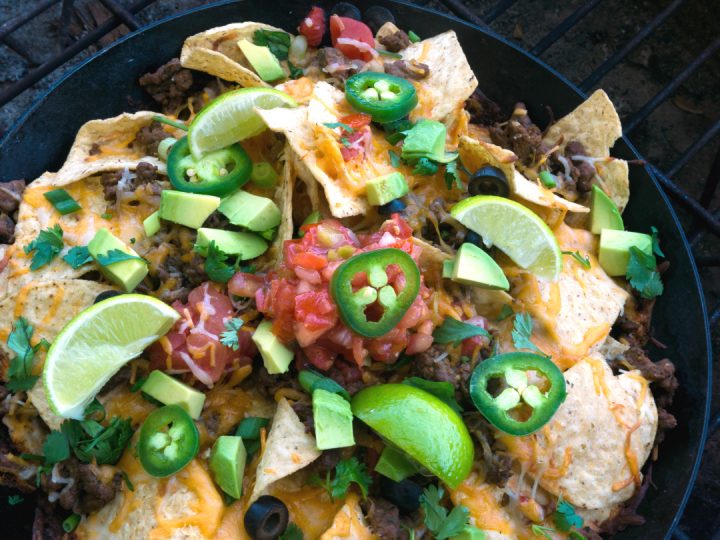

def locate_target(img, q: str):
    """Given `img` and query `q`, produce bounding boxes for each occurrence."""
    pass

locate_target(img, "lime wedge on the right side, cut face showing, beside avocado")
[450,195,562,281]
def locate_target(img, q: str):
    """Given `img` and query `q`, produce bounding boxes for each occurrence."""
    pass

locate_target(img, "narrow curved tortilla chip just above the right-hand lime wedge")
[458,136,590,213]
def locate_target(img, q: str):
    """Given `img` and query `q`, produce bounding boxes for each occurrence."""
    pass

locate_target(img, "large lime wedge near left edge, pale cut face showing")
[42,294,180,420]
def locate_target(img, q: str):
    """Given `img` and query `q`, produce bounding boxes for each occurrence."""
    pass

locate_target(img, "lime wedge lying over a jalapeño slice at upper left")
[188,88,297,158]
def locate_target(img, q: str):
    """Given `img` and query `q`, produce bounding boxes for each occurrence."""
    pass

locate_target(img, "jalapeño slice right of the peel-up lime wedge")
[470,352,566,436]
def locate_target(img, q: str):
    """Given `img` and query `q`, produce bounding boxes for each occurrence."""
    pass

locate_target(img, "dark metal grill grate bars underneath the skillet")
[0,0,720,539]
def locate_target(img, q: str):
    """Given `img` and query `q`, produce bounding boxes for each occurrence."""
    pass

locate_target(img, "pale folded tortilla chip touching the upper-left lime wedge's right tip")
[258,81,369,218]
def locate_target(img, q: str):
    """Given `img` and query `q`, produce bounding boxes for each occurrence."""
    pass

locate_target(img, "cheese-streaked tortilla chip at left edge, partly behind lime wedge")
[0,279,112,429]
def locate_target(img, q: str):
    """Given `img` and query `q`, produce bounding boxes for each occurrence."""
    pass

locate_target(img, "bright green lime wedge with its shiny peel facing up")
[352,384,475,488]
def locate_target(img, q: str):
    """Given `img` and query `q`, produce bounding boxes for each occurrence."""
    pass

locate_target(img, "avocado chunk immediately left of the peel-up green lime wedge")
[313,388,355,450]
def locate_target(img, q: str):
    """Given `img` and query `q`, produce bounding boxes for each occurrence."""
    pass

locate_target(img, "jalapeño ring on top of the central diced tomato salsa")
[330,248,420,337]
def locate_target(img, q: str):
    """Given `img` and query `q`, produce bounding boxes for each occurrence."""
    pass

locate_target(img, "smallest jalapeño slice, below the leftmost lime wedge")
[137,405,200,478]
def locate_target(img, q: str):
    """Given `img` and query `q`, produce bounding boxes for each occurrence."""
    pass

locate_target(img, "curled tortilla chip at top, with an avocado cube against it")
[180,22,289,87]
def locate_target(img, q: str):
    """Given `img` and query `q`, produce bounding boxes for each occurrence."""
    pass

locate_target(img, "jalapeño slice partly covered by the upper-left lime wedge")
[167,137,253,197]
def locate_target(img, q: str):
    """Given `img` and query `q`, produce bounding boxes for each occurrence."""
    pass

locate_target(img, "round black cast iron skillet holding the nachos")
[0,0,711,539]
